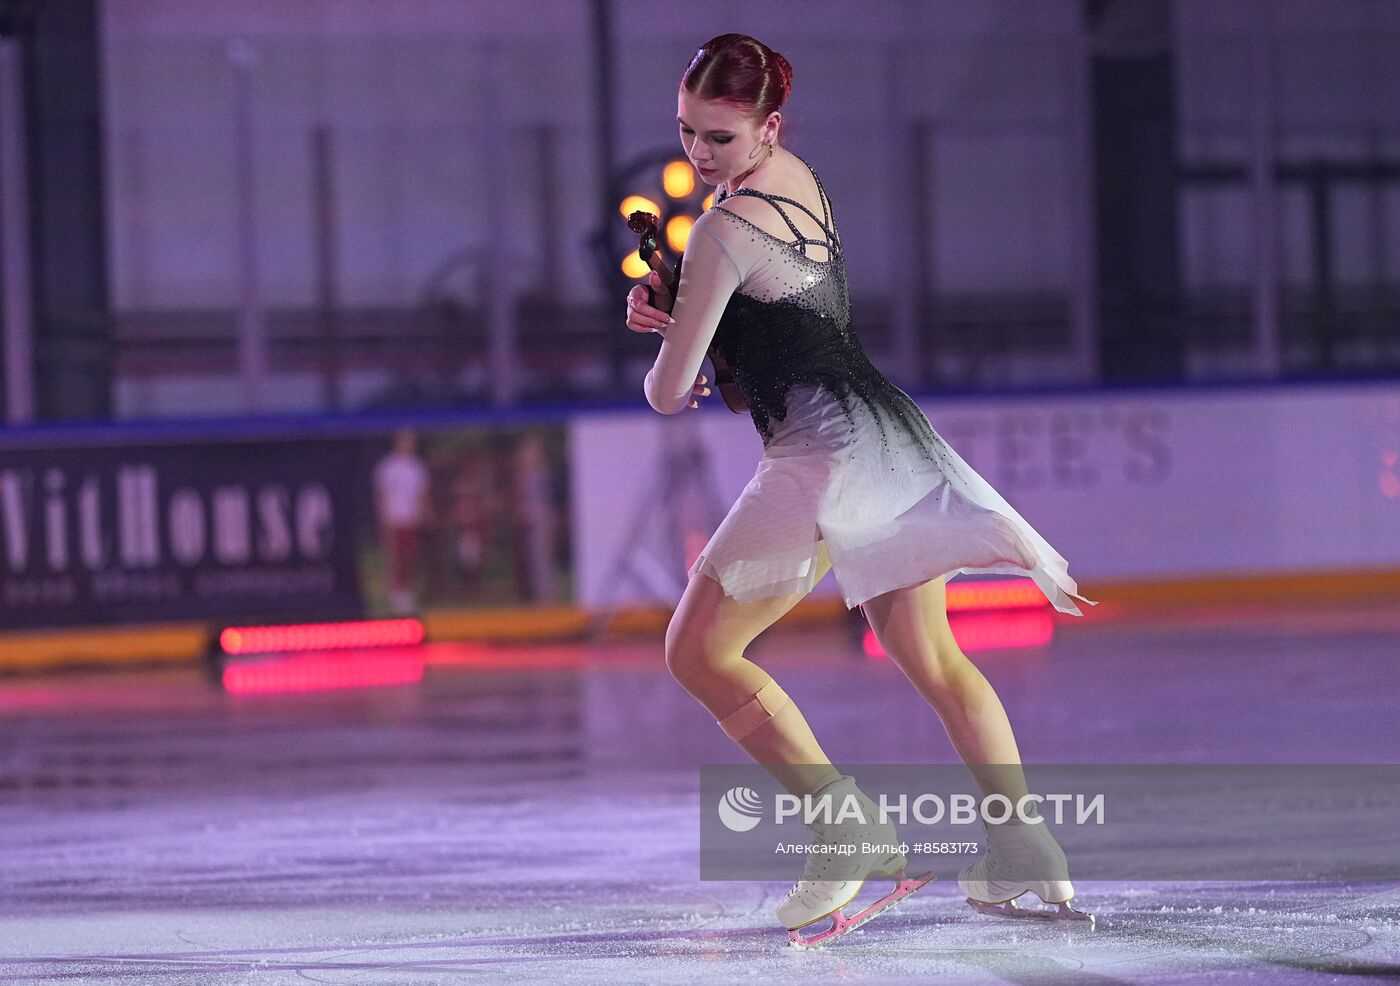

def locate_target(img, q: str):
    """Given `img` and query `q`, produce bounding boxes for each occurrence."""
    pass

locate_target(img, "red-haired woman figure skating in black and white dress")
[627,34,1095,944]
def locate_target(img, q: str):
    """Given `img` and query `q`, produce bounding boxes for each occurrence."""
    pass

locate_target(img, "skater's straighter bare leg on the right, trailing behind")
[864,576,1026,804]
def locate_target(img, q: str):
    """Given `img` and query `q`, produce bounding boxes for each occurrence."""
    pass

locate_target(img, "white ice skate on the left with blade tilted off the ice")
[778,776,934,948]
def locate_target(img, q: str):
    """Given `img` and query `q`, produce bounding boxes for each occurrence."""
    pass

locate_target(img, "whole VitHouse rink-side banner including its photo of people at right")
[0,423,571,632]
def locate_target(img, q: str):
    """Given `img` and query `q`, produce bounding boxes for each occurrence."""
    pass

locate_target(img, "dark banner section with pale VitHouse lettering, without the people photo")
[0,440,363,629]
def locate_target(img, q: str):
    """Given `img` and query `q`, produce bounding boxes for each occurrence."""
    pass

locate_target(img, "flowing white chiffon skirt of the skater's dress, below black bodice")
[690,387,1098,616]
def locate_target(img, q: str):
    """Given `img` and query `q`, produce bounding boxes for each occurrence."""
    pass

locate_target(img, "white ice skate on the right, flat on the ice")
[958,822,1093,927]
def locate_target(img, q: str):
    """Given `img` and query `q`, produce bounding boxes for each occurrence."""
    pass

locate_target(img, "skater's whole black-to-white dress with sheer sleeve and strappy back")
[645,151,1098,615]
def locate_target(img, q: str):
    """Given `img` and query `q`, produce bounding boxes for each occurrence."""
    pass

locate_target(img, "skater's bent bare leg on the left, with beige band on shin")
[666,543,840,796]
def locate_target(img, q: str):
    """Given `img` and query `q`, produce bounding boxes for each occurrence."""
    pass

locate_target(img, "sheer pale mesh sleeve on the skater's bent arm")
[644,209,743,415]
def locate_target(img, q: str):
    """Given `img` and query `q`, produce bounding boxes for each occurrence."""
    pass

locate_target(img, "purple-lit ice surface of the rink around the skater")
[0,604,1400,986]
